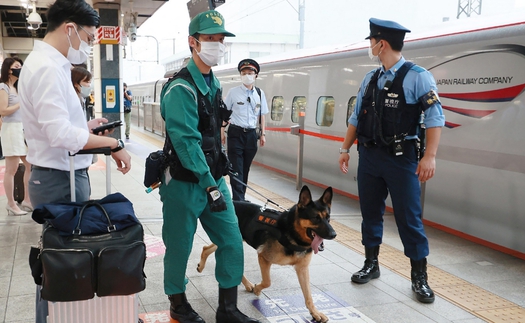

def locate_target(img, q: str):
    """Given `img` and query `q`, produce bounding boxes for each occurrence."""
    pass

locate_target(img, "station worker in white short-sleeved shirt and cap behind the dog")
[224,58,268,201]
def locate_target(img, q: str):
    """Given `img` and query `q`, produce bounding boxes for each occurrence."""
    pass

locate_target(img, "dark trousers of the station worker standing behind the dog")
[228,125,257,201]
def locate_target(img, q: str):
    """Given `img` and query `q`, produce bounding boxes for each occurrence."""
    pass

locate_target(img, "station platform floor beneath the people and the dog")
[0,128,525,323]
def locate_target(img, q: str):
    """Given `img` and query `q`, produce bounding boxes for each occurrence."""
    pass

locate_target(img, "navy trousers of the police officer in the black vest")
[357,141,429,260]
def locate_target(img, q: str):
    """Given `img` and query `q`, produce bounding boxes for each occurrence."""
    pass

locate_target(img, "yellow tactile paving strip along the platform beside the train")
[242,183,525,323]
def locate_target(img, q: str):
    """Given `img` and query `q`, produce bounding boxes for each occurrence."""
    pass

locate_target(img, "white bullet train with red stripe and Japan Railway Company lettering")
[130,18,525,259]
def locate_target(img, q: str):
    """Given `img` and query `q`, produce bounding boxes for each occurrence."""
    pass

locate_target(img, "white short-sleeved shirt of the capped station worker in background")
[224,84,268,129]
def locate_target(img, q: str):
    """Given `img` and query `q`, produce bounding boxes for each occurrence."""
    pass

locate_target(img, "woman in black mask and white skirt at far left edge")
[0,57,33,215]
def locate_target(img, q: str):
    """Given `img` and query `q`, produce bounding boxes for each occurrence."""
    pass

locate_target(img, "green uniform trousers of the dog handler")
[160,178,244,295]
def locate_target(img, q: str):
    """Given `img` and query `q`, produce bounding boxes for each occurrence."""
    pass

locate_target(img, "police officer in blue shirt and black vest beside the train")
[339,18,445,303]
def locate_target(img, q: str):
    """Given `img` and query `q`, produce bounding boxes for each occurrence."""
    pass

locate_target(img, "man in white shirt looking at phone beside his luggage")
[18,0,131,323]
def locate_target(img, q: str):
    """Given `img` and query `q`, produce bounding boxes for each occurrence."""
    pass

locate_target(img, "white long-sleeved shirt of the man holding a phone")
[18,41,93,171]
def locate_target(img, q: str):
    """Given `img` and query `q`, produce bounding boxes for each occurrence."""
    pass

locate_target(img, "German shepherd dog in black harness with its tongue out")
[197,185,336,322]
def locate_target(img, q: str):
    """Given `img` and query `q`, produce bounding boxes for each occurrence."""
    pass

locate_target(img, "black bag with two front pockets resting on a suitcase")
[39,199,146,302]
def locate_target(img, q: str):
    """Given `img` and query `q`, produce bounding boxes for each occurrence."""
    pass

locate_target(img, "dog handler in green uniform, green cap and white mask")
[160,10,259,323]
